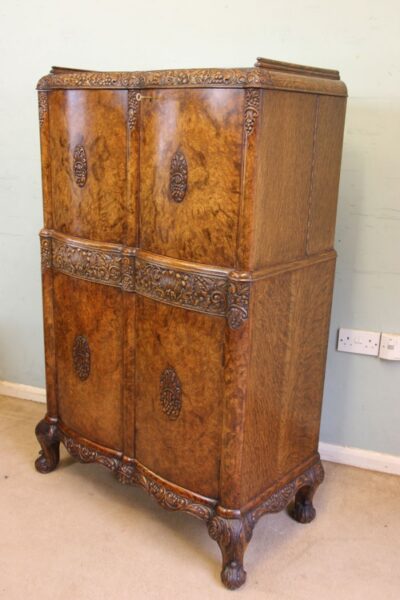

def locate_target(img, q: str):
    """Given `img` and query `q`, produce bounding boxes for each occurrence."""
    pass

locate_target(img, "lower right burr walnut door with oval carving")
[135,297,225,497]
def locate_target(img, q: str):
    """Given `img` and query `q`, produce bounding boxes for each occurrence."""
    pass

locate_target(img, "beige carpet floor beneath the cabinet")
[0,397,400,600]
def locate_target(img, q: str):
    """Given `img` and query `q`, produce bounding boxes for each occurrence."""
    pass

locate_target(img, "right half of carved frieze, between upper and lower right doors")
[135,259,226,316]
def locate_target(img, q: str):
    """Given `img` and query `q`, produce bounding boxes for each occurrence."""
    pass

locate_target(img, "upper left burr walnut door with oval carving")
[49,90,127,242]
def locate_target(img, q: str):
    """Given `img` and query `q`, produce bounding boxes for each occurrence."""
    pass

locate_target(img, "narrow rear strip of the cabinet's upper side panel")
[307,96,346,254]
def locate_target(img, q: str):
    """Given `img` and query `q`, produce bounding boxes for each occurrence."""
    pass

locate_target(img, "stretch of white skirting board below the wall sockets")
[319,442,400,475]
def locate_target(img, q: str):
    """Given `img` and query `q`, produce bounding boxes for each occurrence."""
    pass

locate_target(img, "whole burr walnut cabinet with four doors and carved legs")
[36,59,346,589]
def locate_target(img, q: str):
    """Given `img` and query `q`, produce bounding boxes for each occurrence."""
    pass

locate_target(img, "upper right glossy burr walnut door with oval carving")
[140,89,244,266]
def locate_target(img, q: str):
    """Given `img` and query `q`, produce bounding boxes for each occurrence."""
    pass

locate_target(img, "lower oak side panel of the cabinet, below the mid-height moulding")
[242,259,334,505]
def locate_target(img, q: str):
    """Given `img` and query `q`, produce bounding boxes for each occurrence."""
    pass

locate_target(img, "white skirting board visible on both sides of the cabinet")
[0,380,400,475]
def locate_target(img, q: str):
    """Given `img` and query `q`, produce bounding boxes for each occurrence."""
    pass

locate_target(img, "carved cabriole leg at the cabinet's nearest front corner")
[208,516,253,590]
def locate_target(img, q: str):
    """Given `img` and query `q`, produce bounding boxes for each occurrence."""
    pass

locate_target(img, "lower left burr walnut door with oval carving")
[54,273,123,450]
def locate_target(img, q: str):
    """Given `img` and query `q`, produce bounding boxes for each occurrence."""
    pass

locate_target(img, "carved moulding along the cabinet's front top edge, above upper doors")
[37,68,271,90]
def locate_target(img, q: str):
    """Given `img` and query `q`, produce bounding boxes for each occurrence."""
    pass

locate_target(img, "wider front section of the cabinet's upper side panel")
[251,91,316,268]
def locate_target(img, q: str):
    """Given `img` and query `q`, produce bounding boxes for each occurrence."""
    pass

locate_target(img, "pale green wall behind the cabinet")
[0,0,400,454]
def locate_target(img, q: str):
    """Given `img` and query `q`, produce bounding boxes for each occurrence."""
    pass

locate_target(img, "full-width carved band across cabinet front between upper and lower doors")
[41,231,251,329]
